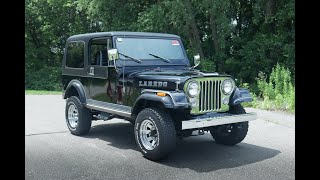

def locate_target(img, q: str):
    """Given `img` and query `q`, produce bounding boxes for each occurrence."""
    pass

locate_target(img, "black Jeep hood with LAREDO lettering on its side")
[127,69,229,90]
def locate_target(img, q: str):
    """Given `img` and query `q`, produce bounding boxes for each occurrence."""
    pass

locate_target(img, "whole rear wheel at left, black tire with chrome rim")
[65,96,92,136]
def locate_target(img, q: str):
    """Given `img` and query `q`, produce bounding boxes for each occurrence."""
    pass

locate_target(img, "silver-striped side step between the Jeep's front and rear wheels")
[86,99,131,117]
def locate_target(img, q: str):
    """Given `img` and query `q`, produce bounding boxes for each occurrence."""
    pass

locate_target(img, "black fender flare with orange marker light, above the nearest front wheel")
[132,91,190,114]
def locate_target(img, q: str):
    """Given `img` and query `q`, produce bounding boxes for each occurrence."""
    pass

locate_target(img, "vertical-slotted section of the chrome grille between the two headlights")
[199,80,222,112]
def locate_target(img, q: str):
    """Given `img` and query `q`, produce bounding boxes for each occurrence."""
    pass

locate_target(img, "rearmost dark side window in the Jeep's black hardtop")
[66,42,84,68]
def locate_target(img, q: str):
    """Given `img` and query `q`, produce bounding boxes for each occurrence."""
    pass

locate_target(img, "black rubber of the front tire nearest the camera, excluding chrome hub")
[134,108,176,161]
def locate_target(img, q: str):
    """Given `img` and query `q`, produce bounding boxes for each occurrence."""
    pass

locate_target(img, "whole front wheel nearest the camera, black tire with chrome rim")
[134,108,176,161]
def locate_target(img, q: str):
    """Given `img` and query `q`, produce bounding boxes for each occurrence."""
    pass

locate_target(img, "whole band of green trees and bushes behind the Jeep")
[25,0,295,112]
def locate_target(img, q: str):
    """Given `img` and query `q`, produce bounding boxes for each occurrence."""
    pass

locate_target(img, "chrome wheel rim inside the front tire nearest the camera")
[139,119,159,151]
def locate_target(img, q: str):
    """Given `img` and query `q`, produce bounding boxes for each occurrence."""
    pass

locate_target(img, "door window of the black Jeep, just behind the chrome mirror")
[89,38,112,66]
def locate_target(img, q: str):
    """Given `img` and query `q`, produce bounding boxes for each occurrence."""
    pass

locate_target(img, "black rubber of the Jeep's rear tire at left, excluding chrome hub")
[65,96,92,136]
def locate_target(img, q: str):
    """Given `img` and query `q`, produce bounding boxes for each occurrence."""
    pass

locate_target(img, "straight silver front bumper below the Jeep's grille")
[182,112,257,130]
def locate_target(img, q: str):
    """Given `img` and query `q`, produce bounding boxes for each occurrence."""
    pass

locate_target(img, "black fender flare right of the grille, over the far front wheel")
[229,88,253,106]
